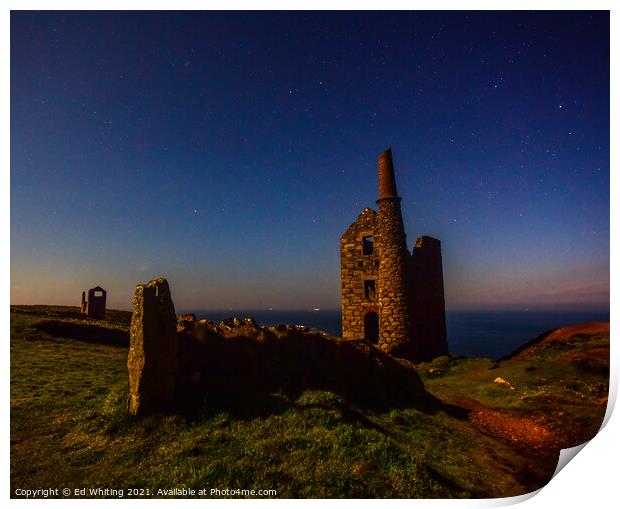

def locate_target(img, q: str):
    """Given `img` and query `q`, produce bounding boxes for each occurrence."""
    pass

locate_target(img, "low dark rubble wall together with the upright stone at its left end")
[127,278,437,415]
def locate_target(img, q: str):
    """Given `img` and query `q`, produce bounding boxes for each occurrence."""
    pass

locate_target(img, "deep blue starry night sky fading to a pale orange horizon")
[11,11,609,309]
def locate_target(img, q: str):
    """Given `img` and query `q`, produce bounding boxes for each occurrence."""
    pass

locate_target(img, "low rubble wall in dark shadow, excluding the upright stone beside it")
[177,330,438,415]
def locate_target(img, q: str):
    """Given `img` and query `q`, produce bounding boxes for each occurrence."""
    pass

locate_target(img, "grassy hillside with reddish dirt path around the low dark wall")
[11,306,609,497]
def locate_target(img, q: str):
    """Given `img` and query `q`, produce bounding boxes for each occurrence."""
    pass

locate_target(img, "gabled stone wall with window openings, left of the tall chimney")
[340,208,380,339]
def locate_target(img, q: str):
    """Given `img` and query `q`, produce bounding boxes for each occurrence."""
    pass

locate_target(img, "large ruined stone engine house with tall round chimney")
[340,149,448,361]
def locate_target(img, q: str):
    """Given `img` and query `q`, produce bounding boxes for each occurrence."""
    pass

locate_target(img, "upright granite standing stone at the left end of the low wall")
[127,278,179,415]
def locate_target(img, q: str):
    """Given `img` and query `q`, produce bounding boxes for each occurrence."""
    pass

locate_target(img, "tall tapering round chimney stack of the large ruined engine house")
[376,148,411,356]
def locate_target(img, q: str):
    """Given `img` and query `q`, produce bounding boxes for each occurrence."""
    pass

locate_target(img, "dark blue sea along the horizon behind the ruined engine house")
[179,310,609,359]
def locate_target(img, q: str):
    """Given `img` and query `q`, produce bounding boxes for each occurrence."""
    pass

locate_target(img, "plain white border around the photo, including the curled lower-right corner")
[0,0,620,508]
